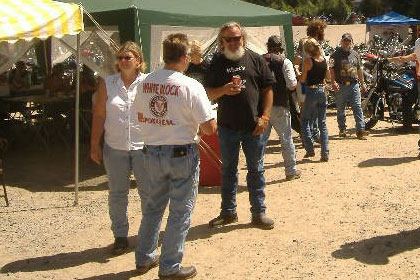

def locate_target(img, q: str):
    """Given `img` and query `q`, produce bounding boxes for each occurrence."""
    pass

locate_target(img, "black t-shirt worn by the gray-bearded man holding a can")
[205,49,276,131]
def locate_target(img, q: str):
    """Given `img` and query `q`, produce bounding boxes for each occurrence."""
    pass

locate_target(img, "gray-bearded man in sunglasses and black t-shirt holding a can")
[205,22,276,229]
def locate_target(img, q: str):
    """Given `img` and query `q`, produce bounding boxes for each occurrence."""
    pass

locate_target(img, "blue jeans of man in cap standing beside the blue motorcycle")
[335,84,365,131]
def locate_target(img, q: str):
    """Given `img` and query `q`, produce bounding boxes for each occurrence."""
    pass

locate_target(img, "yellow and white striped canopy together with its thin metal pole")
[0,0,84,205]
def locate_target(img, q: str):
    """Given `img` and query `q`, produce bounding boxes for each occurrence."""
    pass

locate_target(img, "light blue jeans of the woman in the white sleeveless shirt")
[103,143,144,237]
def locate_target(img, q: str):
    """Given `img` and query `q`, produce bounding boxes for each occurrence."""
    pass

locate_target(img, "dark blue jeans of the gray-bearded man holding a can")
[218,126,266,215]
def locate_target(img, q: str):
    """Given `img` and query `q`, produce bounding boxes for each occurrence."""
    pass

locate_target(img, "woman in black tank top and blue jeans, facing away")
[300,38,329,162]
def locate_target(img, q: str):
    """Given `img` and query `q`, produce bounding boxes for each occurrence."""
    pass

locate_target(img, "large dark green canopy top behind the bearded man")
[61,0,293,70]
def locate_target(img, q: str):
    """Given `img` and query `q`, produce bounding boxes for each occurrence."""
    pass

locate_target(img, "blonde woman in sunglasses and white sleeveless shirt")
[90,42,146,254]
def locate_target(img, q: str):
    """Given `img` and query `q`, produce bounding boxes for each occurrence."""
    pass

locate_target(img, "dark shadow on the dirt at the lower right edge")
[332,228,420,265]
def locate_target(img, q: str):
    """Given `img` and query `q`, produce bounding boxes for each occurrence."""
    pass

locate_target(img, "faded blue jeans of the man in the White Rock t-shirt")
[135,144,199,275]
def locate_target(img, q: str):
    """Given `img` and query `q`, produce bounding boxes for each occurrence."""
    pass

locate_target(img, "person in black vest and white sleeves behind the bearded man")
[263,35,301,181]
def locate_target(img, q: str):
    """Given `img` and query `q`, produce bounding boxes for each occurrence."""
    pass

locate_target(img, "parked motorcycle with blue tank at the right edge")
[362,58,419,129]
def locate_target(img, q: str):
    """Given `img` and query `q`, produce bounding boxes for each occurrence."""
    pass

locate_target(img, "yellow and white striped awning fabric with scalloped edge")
[0,0,83,42]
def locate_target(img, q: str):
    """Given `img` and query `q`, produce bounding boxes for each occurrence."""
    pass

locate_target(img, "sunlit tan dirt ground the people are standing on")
[0,111,420,280]
